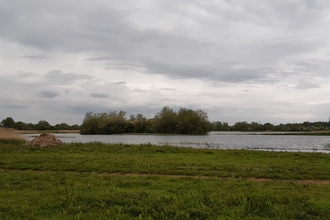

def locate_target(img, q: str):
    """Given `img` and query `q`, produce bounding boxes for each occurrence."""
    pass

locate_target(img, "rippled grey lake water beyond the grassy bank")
[25,132,330,153]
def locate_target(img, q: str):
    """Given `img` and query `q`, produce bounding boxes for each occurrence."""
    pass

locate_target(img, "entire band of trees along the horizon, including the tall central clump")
[0,106,330,134]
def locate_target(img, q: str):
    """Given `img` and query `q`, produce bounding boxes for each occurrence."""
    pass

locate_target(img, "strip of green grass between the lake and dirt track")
[0,140,330,180]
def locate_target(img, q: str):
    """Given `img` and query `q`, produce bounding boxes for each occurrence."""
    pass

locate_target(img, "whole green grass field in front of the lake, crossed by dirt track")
[0,139,330,219]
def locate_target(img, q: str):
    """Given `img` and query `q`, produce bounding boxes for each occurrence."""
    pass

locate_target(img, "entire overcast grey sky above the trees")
[0,0,330,125]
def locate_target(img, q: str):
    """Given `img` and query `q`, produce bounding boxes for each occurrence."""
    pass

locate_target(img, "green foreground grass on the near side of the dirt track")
[0,170,330,219]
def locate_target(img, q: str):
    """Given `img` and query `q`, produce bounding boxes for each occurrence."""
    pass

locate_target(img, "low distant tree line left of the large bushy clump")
[0,117,80,130]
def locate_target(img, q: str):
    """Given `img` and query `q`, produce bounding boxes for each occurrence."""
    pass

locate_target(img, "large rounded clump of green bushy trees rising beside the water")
[80,106,209,135]
